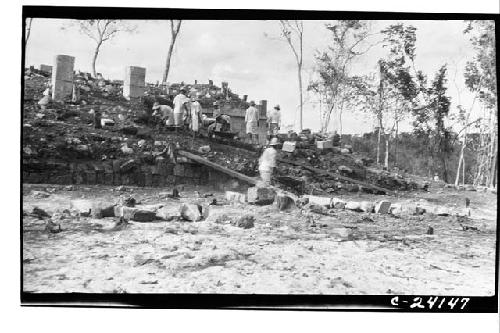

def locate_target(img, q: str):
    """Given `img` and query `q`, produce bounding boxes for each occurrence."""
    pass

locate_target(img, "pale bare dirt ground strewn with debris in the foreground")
[22,185,497,296]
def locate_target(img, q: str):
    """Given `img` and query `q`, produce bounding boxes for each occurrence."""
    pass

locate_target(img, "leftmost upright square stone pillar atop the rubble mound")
[52,54,75,101]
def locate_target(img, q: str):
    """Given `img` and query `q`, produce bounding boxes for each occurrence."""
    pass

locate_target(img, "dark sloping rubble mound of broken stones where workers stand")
[22,69,423,195]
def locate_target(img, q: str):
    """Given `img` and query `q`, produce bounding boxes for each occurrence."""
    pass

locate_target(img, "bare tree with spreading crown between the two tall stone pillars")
[62,20,136,77]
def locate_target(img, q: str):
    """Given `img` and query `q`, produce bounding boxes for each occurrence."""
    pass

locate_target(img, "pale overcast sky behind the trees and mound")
[26,19,482,133]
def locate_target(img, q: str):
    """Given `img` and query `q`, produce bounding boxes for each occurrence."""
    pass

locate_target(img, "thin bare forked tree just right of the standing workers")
[280,20,304,131]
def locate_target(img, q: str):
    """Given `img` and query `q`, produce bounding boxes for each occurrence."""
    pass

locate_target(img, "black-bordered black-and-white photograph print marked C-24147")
[20,1,498,312]
